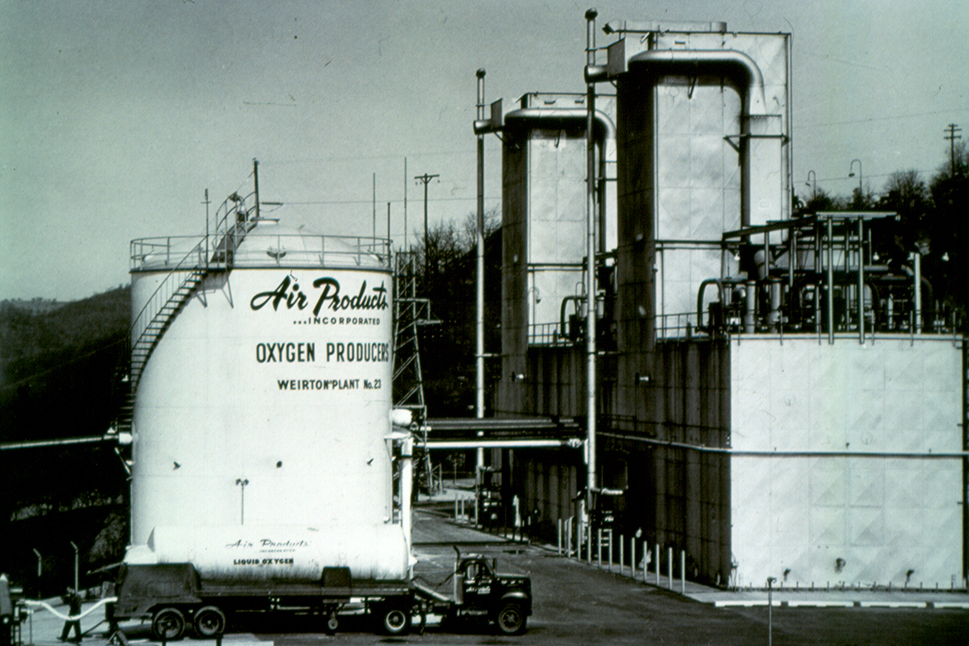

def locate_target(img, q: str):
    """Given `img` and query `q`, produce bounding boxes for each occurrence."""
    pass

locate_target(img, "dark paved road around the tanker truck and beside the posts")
[17,506,969,646]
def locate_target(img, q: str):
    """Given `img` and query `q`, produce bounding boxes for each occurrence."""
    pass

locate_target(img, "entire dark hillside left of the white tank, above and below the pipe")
[0,287,131,596]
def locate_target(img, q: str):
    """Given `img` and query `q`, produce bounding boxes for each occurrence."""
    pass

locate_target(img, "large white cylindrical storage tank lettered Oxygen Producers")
[131,220,403,576]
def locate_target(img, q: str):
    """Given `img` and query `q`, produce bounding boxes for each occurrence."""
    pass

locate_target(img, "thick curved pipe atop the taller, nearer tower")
[629,49,767,116]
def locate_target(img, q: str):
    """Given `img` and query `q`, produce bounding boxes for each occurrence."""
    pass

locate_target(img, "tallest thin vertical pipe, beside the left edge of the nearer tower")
[585,9,598,512]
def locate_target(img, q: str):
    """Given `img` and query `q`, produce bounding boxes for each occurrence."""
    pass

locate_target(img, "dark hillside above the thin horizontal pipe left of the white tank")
[0,287,131,442]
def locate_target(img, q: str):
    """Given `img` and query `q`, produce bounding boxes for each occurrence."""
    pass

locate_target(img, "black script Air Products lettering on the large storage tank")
[249,274,390,316]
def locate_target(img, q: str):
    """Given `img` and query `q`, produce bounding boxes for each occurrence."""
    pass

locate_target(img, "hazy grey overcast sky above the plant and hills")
[0,0,969,300]
